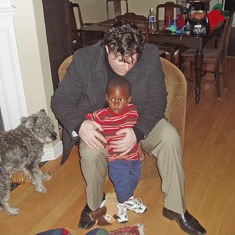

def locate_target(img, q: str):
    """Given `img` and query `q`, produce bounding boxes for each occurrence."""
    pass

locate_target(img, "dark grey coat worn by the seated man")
[51,42,167,163]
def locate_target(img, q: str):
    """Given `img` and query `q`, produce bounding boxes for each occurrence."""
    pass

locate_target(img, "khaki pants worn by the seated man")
[79,119,186,214]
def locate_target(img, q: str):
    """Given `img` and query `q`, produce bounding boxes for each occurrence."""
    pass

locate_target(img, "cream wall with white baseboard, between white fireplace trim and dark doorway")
[8,0,62,160]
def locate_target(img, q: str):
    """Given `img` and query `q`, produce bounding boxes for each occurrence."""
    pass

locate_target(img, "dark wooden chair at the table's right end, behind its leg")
[181,13,234,97]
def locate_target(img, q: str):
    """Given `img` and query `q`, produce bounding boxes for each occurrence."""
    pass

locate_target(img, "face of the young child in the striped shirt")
[106,87,132,114]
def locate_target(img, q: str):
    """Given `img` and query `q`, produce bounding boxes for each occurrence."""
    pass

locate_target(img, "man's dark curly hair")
[102,19,144,61]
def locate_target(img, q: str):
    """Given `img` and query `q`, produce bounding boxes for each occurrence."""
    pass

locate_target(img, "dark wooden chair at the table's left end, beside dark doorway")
[69,2,100,51]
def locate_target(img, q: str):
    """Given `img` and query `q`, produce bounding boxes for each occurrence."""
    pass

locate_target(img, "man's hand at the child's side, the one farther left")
[78,120,107,150]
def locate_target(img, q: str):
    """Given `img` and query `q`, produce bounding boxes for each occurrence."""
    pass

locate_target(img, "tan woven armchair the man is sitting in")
[58,55,187,179]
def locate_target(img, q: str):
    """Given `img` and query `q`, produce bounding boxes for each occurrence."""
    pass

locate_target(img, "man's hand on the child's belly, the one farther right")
[110,128,137,156]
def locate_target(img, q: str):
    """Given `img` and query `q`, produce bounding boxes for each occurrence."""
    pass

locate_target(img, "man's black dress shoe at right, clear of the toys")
[163,207,206,235]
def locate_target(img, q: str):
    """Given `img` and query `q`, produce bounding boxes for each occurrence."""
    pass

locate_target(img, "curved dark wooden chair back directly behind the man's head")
[115,12,149,42]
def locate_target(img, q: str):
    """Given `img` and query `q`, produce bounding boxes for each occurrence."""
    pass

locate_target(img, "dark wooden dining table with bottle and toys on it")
[81,19,223,104]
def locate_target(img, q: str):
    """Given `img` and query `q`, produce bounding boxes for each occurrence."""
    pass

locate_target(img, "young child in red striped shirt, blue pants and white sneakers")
[86,77,147,223]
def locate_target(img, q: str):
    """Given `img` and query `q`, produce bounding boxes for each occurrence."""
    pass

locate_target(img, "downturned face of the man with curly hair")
[105,46,137,76]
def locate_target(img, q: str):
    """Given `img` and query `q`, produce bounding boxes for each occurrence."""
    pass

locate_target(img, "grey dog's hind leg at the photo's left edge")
[0,171,20,215]
